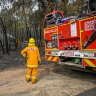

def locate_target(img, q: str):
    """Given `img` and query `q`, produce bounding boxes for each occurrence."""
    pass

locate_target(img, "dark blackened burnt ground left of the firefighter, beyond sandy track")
[0,51,25,71]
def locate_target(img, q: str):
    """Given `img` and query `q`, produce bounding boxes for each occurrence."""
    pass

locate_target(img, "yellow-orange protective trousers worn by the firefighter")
[26,67,38,81]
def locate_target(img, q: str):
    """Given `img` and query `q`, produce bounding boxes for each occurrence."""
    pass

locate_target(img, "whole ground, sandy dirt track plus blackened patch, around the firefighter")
[0,51,96,96]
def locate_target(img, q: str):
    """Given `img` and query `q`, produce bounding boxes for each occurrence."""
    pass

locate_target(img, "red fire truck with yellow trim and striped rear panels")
[44,0,96,70]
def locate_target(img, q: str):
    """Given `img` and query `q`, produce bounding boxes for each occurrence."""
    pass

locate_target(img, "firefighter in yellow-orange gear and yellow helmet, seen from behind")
[21,38,41,84]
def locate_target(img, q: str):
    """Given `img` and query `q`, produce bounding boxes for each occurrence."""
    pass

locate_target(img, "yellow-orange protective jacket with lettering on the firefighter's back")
[21,44,41,68]
